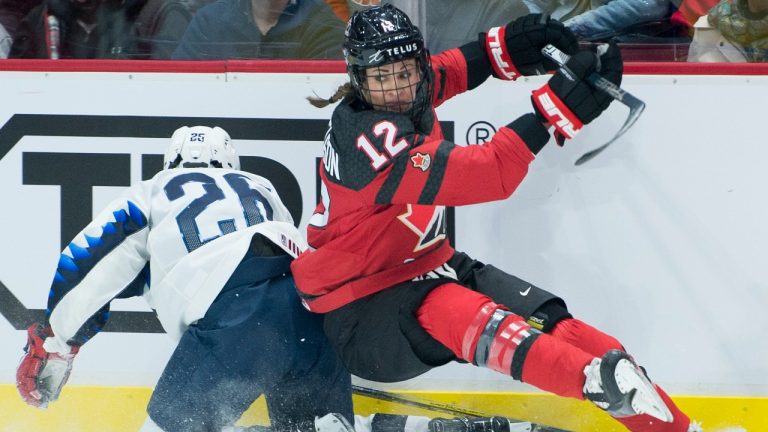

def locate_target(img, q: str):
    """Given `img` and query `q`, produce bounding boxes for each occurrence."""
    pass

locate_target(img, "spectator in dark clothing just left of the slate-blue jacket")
[134,0,214,60]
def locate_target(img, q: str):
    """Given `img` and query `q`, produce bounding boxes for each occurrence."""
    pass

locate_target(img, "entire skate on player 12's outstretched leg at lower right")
[584,350,673,422]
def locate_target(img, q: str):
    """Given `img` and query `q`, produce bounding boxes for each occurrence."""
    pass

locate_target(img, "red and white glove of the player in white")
[16,323,80,408]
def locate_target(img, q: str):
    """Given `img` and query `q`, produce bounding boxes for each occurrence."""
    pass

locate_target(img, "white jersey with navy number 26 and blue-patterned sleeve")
[45,168,306,353]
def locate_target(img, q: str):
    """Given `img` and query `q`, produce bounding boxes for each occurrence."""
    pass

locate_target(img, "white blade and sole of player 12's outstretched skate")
[614,360,674,423]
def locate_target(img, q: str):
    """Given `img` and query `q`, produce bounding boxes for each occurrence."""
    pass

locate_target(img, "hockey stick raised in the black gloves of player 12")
[541,45,645,165]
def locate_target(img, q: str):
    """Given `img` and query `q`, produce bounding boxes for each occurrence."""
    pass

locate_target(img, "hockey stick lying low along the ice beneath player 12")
[352,384,568,432]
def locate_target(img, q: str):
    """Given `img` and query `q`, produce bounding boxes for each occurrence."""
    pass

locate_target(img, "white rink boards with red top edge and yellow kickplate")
[0,61,768,432]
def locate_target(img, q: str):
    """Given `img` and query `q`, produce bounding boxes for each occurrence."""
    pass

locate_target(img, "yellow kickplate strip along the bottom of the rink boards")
[0,385,768,432]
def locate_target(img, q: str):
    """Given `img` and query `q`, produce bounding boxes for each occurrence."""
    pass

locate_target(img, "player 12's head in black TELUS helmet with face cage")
[344,4,432,122]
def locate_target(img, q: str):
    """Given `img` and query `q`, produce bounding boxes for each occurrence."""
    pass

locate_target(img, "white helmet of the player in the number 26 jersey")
[163,126,240,170]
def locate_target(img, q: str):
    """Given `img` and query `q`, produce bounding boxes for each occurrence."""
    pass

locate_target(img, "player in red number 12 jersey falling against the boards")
[291,5,693,432]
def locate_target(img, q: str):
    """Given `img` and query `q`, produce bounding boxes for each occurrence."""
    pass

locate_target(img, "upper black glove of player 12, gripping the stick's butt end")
[480,14,579,80]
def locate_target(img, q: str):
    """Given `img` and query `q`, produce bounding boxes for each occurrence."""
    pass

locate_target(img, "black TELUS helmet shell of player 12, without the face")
[344,4,432,120]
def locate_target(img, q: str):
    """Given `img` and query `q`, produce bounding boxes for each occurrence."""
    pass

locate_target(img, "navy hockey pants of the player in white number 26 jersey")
[147,252,354,432]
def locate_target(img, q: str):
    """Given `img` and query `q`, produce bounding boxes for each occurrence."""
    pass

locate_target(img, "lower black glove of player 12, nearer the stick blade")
[531,44,624,145]
